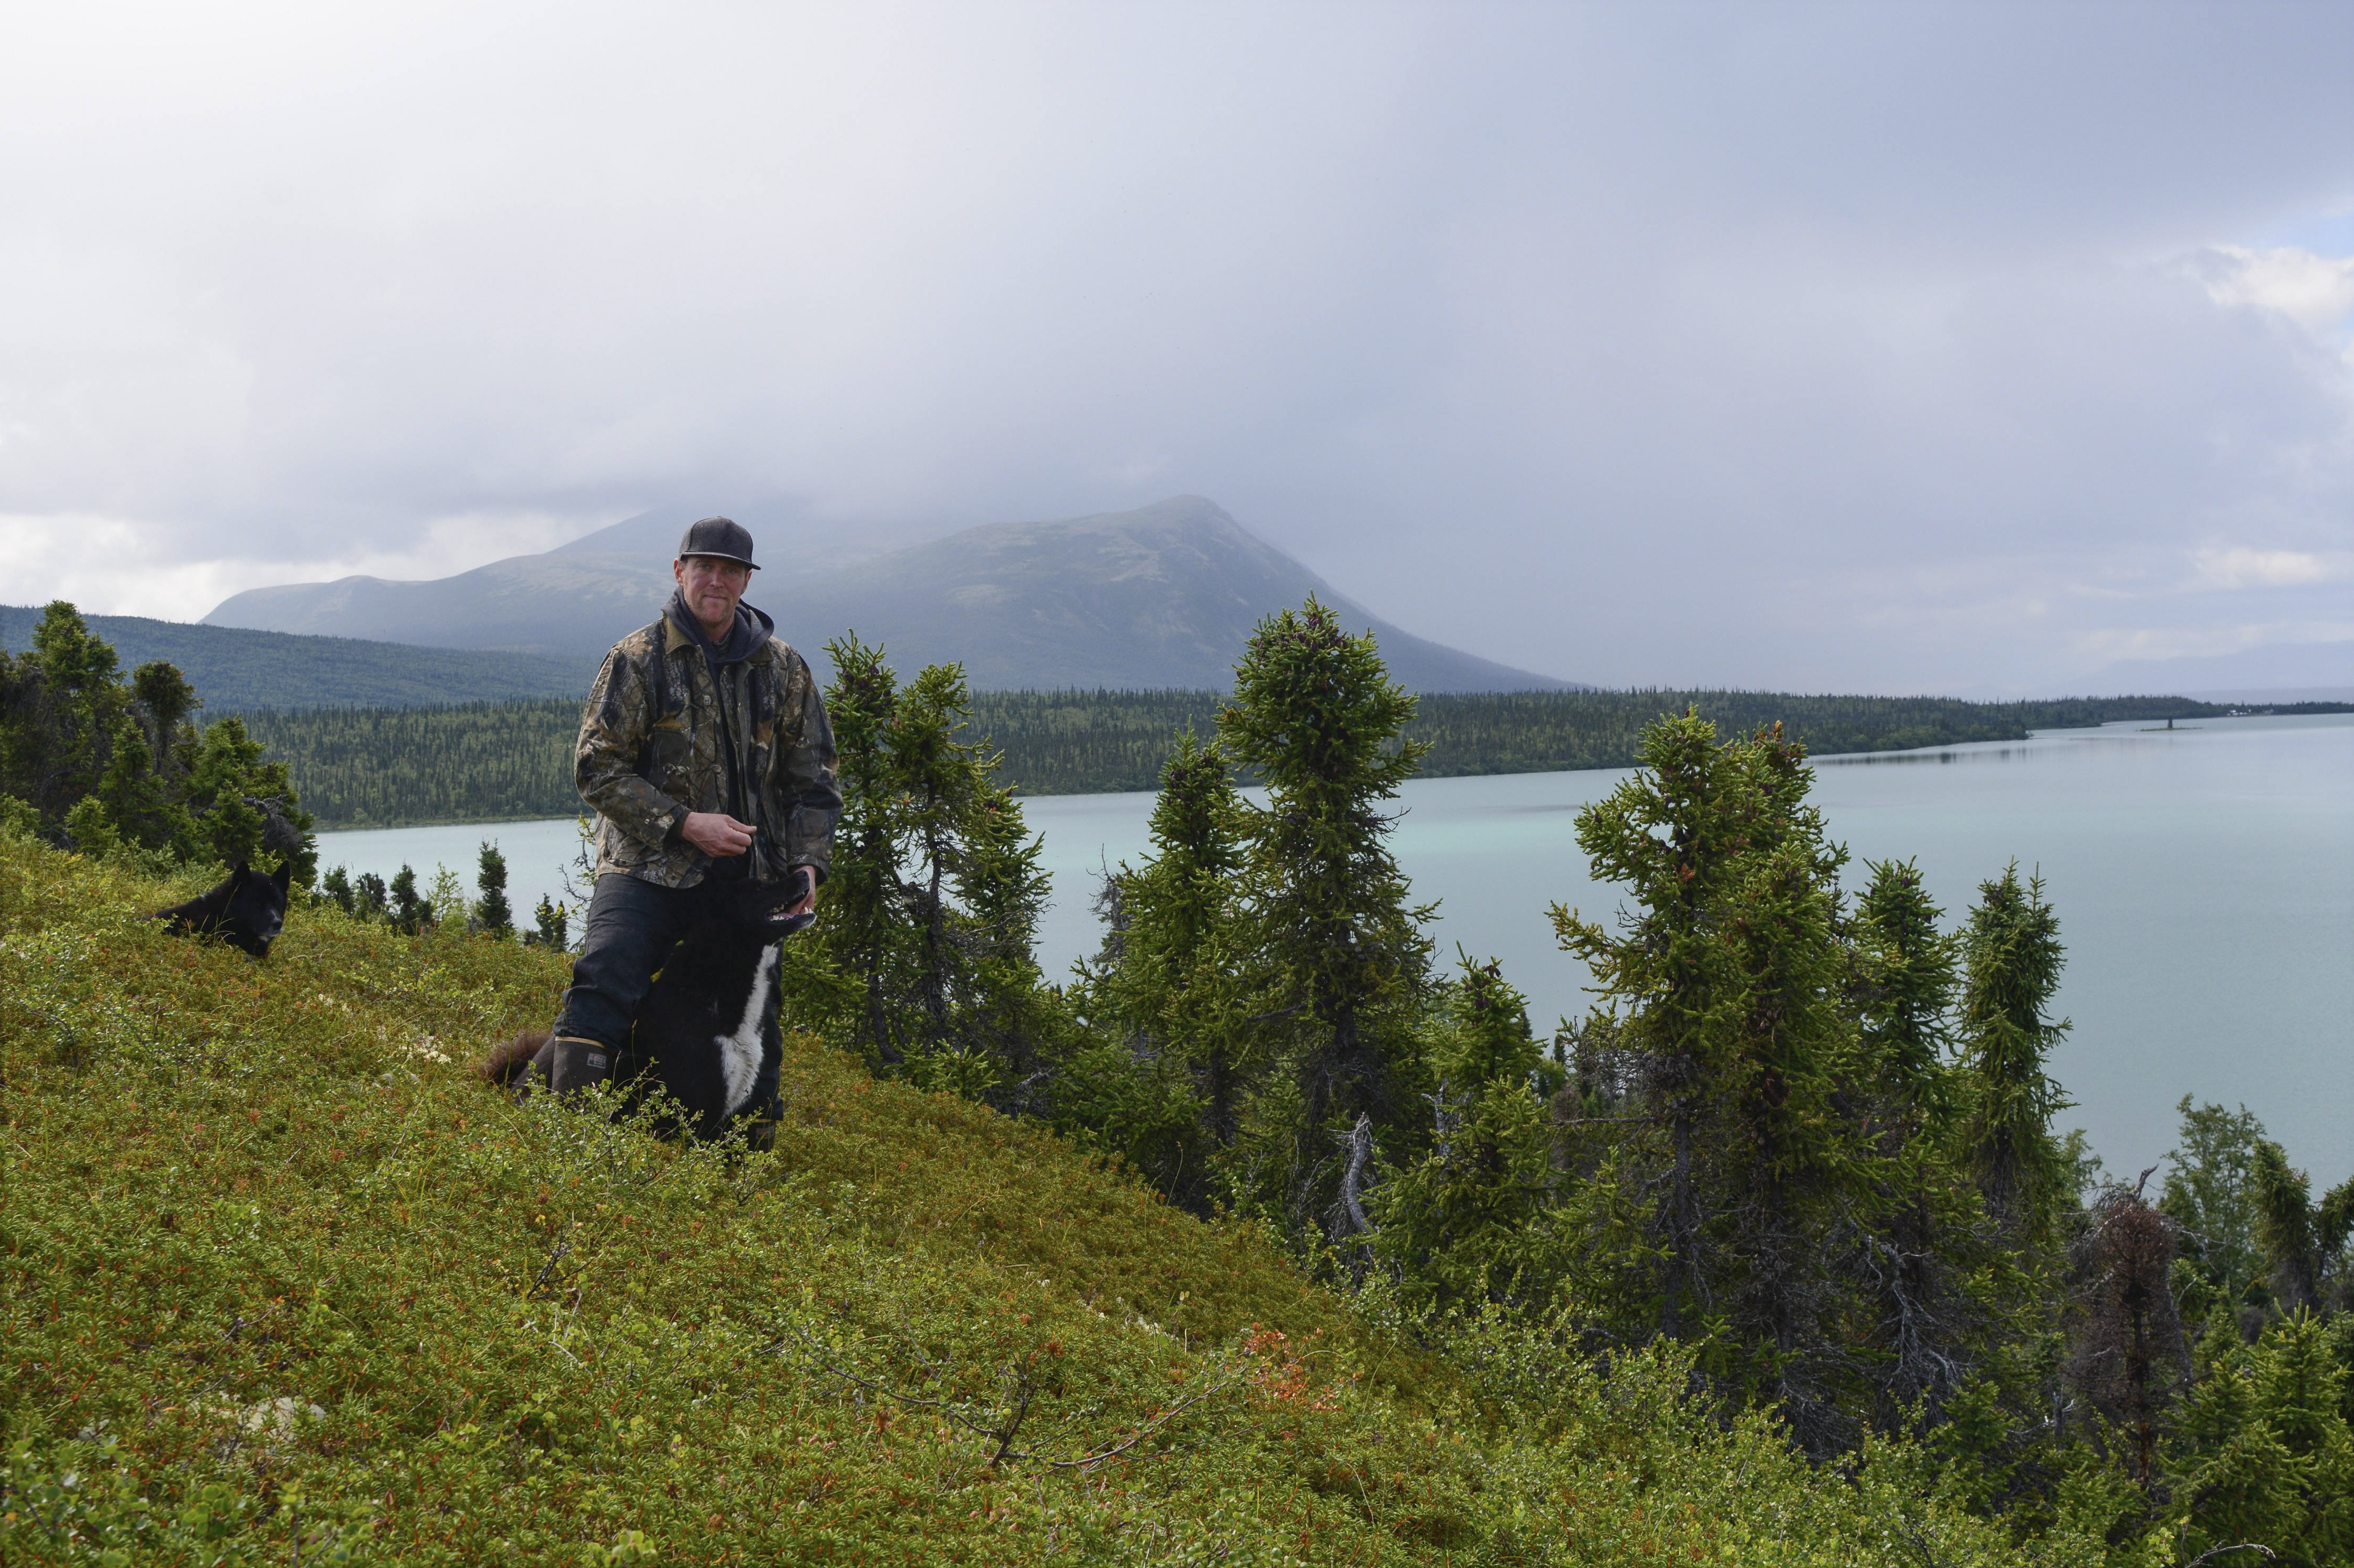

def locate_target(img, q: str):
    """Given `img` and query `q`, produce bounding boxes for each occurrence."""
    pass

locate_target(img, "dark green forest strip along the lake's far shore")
[245,690,2321,829]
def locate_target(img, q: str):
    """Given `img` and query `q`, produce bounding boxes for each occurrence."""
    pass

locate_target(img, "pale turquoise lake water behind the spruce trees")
[320,713,2354,1172]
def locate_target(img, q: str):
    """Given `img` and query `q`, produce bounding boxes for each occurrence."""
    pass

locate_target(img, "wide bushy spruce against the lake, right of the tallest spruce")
[1554,713,1904,1453]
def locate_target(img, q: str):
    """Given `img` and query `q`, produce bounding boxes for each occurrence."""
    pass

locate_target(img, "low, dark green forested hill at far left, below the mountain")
[0,605,595,718]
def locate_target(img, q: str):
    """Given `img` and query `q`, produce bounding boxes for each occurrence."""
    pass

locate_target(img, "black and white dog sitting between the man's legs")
[475,876,810,1149]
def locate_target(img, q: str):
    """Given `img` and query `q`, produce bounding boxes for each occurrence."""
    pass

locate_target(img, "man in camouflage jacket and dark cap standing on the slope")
[548,518,843,1104]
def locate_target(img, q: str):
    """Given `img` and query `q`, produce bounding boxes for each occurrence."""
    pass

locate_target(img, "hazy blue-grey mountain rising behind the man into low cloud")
[205,497,1573,692]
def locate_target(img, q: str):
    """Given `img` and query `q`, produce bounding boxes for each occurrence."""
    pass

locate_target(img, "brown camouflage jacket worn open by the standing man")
[572,610,843,888]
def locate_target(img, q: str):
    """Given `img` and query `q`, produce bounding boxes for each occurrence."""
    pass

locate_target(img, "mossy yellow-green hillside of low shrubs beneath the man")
[0,841,2067,1563]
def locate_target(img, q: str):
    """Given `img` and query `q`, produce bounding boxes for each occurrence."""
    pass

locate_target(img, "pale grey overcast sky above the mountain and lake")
[0,0,2354,690]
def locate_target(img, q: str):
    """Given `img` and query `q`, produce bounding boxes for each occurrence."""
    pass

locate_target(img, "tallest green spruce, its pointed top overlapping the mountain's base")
[1217,598,1429,1241]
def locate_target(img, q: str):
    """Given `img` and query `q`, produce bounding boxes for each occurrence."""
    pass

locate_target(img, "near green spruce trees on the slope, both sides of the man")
[14,598,2354,1563]
